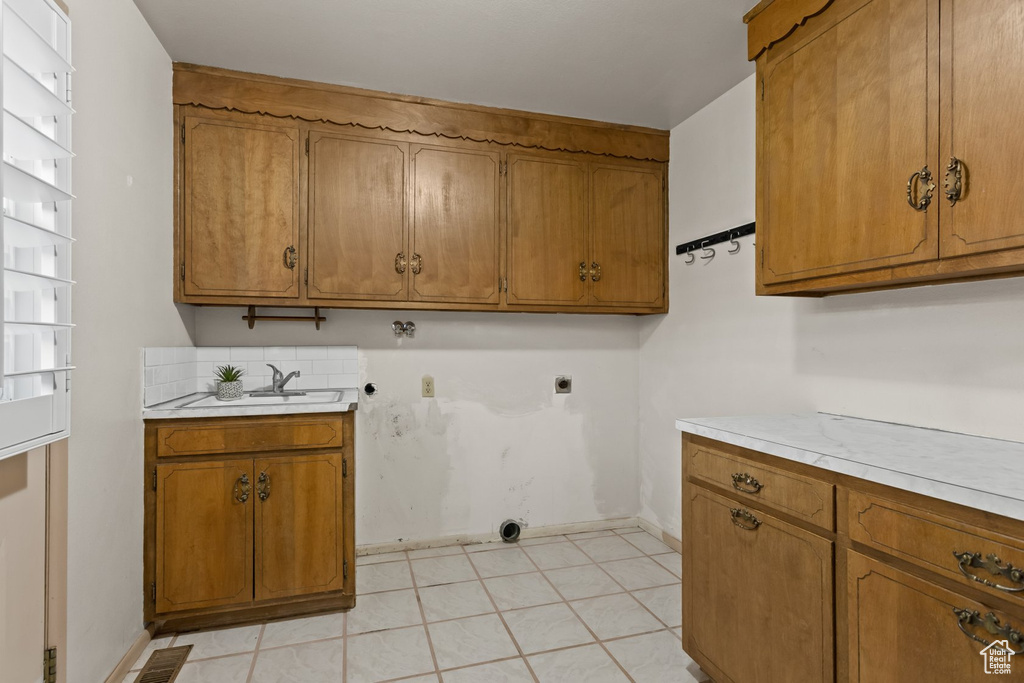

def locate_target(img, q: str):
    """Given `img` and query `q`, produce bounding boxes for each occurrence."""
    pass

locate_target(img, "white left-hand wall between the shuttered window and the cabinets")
[67,0,194,683]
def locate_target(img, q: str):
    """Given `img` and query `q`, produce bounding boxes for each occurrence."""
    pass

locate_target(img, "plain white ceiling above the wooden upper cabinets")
[135,0,755,128]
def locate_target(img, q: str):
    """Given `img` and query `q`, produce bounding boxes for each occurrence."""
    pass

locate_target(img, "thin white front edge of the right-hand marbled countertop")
[676,420,1024,521]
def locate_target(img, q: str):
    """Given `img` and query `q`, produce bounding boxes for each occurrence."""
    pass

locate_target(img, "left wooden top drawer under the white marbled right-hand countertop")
[687,445,835,530]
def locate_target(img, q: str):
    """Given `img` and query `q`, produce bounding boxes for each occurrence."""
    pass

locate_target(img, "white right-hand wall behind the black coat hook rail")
[640,77,1024,537]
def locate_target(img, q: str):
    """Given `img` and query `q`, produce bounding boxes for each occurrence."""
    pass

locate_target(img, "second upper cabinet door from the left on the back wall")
[309,132,409,301]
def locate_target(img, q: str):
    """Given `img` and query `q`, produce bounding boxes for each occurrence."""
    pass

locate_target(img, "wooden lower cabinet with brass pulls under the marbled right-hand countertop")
[682,434,1024,683]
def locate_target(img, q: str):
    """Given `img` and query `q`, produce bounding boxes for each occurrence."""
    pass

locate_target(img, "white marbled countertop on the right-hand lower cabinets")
[676,413,1024,520]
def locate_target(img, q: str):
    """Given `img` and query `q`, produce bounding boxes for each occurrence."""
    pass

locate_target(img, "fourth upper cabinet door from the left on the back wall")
[508,155,590,305]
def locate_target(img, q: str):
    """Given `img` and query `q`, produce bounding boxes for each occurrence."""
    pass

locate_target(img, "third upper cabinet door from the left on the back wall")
[410,145,501,304]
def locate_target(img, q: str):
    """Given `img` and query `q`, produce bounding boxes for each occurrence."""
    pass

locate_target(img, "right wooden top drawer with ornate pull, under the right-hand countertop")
[850,490,1024,603]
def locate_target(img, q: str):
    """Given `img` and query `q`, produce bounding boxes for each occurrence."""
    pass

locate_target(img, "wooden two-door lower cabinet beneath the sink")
[144,413,355,632]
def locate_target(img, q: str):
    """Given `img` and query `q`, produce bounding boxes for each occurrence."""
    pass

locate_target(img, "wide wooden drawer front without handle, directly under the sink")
[157,417,342,457]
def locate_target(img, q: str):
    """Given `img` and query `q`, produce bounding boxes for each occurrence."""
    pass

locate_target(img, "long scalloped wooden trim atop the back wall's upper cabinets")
[173,63,669,162]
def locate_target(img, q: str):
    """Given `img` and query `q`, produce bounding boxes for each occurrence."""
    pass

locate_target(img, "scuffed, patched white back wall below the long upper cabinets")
[196,308,639,545]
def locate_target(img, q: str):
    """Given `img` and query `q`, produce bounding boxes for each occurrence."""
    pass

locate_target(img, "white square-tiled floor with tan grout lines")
[125,527,708,683]
